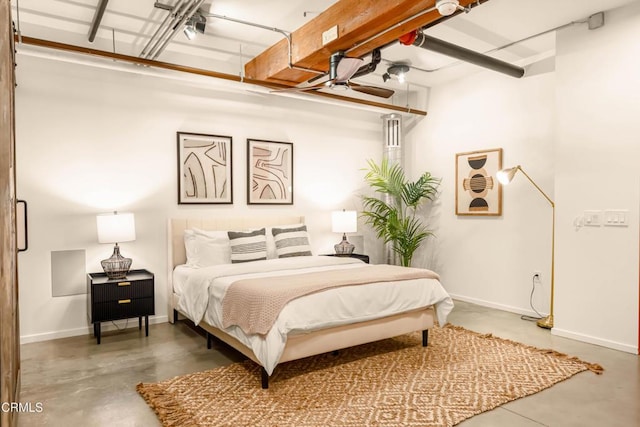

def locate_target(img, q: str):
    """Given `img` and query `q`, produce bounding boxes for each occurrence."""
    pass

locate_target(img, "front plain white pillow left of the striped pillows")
[184,228,231,268]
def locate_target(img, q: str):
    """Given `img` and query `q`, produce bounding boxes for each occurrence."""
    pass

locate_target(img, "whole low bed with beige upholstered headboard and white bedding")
[167,216,453,388]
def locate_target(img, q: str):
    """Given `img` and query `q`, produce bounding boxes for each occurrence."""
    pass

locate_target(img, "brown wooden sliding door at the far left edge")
[0,0,20,427]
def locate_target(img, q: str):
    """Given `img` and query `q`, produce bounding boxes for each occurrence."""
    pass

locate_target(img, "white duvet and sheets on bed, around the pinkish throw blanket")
[174,256,453,374]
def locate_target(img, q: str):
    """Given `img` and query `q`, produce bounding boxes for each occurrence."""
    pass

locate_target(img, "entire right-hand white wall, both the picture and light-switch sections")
[407,3,640,352]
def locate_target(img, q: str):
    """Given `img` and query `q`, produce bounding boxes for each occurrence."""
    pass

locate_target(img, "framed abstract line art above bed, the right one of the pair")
[247,139,293,205]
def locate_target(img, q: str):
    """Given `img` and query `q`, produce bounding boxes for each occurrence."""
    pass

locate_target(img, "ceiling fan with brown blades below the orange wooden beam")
[274,51,394,98]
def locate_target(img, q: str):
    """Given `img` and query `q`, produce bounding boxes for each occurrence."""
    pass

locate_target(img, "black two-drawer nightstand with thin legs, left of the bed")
[87,270,155,344]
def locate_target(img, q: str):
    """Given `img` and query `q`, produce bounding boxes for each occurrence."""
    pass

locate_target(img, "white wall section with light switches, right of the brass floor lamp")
[554,2,640,351]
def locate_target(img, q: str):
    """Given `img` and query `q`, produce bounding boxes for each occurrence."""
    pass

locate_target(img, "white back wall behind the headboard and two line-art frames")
[16,54,382,342]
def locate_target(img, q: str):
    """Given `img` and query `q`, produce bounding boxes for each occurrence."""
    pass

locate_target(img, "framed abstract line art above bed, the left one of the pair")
[177,132,233,205]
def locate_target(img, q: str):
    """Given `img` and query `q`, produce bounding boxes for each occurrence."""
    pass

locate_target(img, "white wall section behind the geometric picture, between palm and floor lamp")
[407,71,554,314]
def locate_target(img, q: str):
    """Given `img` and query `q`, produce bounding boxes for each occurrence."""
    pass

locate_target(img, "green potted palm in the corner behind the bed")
[362,159,440,267]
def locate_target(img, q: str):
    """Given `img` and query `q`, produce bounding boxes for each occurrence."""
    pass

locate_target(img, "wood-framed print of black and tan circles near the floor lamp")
[456,148,502,216]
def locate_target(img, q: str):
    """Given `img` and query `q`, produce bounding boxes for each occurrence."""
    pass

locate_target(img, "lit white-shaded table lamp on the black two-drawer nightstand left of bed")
[96,211,136,279]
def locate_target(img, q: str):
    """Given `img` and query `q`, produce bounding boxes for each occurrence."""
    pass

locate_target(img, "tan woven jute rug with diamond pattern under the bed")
[137,326,602,427]
